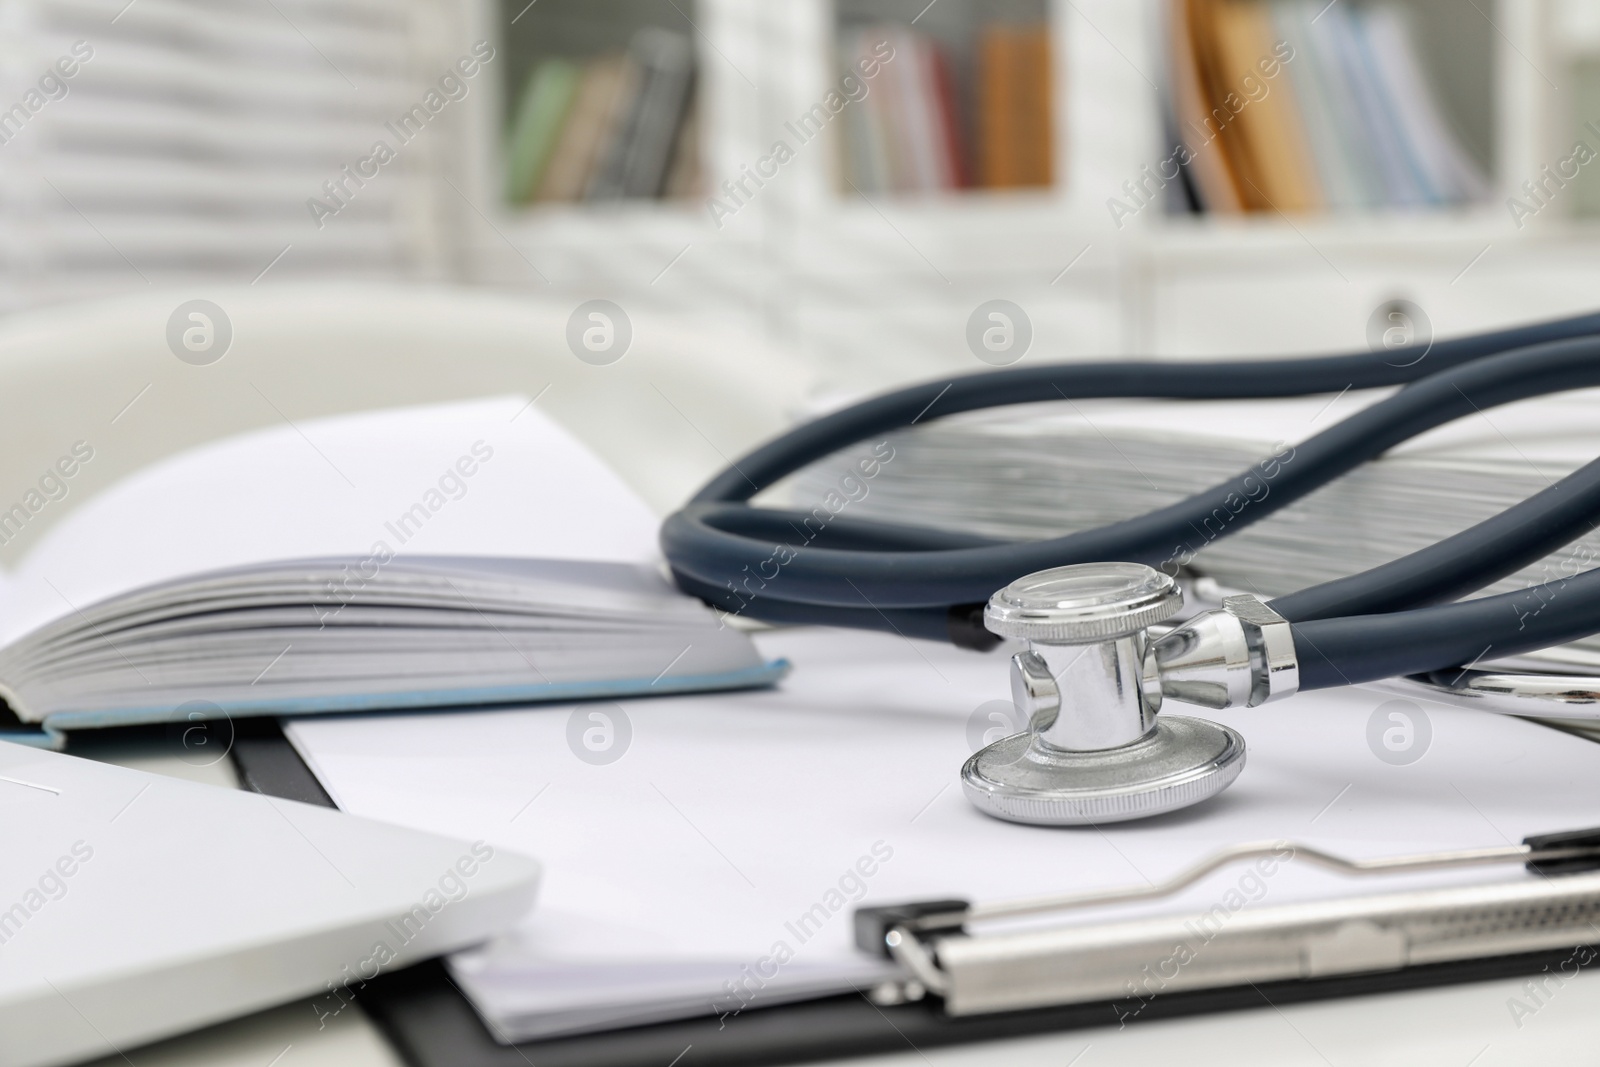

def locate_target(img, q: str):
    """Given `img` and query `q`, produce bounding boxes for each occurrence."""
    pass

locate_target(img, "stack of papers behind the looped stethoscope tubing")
[787,390,1600,662]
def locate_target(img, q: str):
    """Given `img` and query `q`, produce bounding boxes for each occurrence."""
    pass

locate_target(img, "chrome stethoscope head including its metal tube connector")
[962,563,1299,825]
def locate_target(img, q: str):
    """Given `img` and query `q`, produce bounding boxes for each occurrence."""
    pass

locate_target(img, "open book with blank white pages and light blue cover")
[0,397,786,744]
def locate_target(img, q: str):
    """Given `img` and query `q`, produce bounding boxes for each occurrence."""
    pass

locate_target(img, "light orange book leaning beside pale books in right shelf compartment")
[1214,0,1325,211]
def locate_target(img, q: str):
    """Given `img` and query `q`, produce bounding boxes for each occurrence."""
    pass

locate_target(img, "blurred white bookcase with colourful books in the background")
[466,0,1600,387]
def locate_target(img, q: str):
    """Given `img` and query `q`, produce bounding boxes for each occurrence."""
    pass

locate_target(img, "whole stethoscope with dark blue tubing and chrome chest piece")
[661,314,1600,825]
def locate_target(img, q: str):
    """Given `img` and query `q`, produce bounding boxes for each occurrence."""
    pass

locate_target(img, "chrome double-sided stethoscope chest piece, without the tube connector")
[962,563,1259,825]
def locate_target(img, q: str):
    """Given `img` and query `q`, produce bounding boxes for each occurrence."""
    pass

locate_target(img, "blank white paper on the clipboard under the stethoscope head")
[288,630,1600,1036]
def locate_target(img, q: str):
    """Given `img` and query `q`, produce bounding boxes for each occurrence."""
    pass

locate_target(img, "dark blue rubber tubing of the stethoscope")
[662,315,1600,688]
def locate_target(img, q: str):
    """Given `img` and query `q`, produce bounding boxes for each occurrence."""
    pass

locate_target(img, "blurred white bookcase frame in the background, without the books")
[448,0,1600,374]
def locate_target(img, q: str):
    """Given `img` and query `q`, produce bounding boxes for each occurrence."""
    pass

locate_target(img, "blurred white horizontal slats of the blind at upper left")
[0,0,448,307]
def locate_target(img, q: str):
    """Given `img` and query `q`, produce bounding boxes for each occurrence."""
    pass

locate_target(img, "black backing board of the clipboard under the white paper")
[230,720,1600,1067]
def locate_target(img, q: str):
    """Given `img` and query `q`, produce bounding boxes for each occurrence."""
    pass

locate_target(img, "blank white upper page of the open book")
[0,397,658,641]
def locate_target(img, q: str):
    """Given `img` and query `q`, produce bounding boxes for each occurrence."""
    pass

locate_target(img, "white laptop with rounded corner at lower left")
[0,742,539,1067]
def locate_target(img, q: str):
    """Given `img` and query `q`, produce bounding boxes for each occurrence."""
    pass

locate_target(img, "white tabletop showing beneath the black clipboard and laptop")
[74,744,1600,1067]
